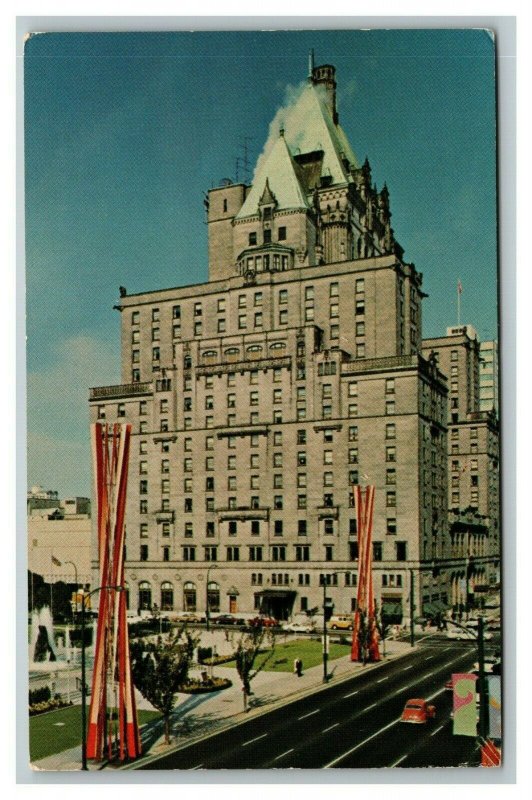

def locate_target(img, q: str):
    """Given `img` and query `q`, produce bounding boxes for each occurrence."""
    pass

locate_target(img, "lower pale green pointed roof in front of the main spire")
[236,135,309,219]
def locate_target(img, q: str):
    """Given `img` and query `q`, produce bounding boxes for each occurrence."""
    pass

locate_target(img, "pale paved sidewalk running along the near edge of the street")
[32,640,411,771]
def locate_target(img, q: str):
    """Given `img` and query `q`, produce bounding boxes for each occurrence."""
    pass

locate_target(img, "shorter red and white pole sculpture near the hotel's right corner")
[351,486,380,661]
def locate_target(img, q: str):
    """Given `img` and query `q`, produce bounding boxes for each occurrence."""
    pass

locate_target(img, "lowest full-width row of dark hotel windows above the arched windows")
[139,542,407,564]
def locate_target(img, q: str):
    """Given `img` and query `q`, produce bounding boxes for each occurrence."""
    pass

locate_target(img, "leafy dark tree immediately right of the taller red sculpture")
[130,627,198,744]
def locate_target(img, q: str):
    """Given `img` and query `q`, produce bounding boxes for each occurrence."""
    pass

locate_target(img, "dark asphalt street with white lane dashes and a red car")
[136,638,479,770]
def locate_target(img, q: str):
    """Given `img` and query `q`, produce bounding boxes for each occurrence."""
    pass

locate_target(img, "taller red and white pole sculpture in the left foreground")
[87,422,141,761]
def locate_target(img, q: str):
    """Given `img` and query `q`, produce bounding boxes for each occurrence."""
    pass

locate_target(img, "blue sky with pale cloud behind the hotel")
[24,30,497,496]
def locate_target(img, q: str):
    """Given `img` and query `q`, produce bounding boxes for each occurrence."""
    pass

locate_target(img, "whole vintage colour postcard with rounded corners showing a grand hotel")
[24,28,498,780]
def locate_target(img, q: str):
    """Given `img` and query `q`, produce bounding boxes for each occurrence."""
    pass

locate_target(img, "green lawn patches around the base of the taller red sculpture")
[30,706,160,761]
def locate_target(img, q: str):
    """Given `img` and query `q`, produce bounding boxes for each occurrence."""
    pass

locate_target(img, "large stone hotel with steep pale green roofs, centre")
[90,65,498,621]
